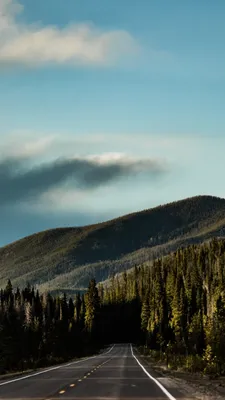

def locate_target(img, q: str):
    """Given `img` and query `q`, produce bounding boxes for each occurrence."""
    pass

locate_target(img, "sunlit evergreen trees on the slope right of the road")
[104,239,225,374]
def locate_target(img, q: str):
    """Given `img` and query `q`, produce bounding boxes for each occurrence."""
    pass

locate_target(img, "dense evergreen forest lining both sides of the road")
[0,239,225,374]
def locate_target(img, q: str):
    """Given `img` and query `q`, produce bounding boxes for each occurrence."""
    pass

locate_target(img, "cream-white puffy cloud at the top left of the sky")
[0,0,139,66]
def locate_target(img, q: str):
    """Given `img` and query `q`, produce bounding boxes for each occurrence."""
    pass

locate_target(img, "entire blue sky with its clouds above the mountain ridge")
[0,0,225,246]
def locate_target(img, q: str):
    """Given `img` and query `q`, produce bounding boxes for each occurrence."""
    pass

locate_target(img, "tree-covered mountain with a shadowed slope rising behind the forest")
[0,194,225,293]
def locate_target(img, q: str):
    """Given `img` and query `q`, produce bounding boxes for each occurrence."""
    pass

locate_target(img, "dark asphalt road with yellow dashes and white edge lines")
[0,344,193,400]
